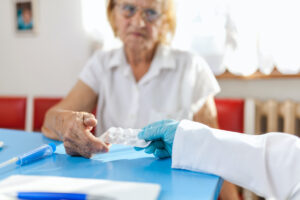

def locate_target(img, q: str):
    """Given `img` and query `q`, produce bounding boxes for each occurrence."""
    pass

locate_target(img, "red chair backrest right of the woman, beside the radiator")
[215,98,245,133]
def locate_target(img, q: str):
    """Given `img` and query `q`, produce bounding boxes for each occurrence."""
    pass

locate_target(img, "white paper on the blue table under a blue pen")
[0,175,160,200]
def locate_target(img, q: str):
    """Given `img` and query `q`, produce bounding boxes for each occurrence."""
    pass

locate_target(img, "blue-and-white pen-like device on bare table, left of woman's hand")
[0,143,56,168]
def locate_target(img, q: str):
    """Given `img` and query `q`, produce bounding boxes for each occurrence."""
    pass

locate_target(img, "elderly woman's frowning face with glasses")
[114,0,163,50]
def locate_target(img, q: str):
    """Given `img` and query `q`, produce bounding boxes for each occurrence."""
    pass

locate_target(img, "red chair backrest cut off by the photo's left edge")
[0,97,27,130]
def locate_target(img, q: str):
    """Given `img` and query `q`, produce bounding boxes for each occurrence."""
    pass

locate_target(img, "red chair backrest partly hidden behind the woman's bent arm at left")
[33,97,62,131]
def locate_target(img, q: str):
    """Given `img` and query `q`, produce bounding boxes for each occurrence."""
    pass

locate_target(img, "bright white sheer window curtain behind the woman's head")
[82,0,300,76]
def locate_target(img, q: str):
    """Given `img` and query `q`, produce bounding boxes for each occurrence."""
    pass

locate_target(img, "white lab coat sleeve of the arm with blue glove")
[172,120,300,200]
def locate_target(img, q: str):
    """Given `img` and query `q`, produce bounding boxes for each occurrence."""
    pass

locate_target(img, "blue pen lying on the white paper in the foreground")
[9,192,114,200]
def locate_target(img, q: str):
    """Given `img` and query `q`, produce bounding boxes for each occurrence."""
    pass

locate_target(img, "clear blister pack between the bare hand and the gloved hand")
[99,127,150,148]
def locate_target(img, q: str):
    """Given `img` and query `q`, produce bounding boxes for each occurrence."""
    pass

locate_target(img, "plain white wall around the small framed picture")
[0,0,90,130]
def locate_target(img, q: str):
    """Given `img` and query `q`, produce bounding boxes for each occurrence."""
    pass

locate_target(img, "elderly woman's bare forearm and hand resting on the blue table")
[42,80,108,158]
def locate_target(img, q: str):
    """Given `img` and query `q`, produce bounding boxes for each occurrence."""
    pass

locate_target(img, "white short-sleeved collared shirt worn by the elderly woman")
[80,45,220,135]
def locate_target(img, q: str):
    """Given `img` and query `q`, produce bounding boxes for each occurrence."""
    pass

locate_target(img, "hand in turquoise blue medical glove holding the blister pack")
[138,120,179,158]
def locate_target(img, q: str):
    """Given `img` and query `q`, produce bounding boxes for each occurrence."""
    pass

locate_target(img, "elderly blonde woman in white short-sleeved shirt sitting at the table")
[42,0,236,199]
